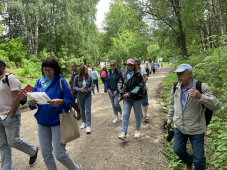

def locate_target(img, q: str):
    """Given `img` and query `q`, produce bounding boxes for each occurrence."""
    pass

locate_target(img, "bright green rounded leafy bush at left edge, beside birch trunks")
[0,38,26,66]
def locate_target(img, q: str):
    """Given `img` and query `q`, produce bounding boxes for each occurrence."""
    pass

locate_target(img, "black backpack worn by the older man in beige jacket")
[173,81,213,126]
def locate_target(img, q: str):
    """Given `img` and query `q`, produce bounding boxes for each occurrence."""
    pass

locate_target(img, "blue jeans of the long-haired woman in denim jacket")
[77,92,91,127]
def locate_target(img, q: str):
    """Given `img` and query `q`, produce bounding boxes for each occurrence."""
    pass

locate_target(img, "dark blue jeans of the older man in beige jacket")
[173,128,206,170]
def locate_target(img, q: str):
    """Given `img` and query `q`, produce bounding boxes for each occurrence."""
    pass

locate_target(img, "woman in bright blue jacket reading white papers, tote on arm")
[29,57,82,170]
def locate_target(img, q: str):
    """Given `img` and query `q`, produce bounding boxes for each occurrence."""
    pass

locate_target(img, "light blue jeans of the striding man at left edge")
[0,114,36,170]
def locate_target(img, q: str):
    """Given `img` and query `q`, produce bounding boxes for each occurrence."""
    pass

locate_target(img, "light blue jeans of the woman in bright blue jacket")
[38,124,78,170]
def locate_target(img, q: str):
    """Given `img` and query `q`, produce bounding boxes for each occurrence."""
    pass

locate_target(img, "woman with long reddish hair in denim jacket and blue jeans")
[73,65,94,134]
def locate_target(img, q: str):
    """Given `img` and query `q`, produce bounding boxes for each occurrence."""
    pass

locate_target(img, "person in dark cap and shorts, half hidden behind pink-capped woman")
[135,59,149,122]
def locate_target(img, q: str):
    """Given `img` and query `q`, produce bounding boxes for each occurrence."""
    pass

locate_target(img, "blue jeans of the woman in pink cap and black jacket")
[122,99,142,134]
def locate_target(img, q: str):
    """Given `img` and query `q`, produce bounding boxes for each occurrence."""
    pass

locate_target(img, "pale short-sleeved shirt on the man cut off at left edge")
[0,73,21,120]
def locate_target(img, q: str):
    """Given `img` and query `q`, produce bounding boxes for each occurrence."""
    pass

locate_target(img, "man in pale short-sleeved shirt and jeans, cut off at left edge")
[0,60,38,170]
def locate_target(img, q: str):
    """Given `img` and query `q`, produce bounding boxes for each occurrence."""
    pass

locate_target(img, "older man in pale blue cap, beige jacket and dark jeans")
[167,64,221,170]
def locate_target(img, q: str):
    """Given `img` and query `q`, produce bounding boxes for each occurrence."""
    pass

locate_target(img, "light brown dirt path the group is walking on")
[7,66,172,170]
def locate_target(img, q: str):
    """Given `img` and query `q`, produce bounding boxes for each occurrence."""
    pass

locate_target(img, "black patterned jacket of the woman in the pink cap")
[117,72,145,100]
